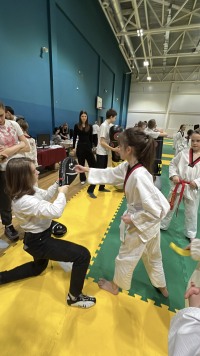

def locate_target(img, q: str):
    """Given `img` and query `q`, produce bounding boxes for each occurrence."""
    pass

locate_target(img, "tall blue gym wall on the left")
[0,0,130,136]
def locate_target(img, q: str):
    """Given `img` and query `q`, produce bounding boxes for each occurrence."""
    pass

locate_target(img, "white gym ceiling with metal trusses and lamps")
[99,0,200,82]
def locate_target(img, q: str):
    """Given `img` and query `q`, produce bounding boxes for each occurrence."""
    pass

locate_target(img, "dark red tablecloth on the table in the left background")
[37,147,66,167]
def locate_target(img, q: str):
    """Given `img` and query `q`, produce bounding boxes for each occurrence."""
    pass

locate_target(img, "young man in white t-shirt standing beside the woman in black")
[88,109,119,198]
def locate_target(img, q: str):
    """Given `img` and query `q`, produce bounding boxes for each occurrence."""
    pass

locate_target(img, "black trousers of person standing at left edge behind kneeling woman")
[0,171,12,226]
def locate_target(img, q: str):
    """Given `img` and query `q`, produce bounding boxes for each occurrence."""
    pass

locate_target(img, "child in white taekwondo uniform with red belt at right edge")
[161,129,200,239]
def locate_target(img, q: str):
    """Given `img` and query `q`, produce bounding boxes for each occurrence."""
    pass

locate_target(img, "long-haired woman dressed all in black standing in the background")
[73,110,96,198]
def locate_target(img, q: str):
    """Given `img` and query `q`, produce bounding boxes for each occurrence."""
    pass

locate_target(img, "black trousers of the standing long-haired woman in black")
[76,144,96,193]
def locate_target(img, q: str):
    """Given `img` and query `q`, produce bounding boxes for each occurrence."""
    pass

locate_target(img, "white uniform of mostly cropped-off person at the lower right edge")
[169,239,200,356]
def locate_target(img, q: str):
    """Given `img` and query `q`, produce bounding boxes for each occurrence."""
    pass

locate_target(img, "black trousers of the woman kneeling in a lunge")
[1,228,91,297]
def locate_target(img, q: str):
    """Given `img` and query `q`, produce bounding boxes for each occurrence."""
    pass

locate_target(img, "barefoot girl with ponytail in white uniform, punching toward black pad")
[75,128,169,297]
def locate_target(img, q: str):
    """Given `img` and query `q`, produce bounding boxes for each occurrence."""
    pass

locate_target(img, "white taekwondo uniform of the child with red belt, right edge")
[161,148,200,239]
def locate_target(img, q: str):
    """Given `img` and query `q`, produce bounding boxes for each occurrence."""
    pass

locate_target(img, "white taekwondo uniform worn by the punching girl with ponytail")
[88,162,169,290]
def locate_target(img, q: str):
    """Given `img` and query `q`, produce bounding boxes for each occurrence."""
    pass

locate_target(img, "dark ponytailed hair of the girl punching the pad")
[119,127,156,174]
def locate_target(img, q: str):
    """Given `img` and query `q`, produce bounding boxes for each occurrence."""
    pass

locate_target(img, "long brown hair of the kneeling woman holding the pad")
[6,157,35,199]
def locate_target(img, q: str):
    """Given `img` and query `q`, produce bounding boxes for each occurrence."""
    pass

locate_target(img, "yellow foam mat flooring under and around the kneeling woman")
[0,187,173,356]
